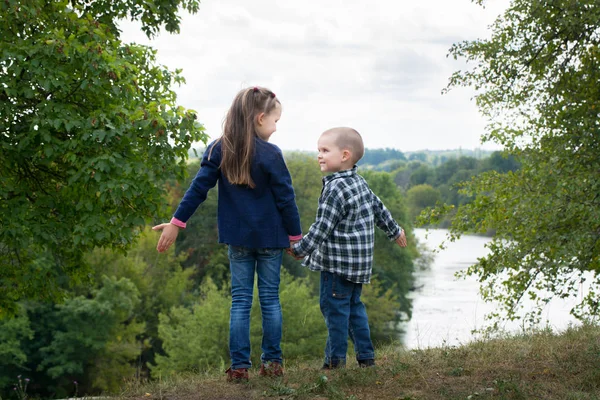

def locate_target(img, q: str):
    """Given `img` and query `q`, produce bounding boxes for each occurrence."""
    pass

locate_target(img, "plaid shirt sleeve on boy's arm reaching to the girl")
[292,184,347,257]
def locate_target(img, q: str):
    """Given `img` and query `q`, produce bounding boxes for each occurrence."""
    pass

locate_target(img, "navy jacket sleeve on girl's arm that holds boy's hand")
[267,151,302,237]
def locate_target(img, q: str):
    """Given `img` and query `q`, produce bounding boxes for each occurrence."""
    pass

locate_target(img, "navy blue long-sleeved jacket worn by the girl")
[174,137,302,248]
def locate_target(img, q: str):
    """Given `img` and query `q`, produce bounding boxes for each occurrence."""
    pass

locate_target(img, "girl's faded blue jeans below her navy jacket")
[228,246,283,369]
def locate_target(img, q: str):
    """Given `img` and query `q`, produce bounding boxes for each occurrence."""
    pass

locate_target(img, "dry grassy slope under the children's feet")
[120,326,600,400]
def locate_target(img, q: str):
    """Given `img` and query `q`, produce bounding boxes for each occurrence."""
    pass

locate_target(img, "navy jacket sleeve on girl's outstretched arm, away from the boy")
[173,142,221,223]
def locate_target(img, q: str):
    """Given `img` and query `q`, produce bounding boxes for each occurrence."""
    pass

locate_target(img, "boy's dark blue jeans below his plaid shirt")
[320,271,375,367]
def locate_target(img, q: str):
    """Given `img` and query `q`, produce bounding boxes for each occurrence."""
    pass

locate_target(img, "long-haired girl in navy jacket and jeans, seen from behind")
[152,87,302,381]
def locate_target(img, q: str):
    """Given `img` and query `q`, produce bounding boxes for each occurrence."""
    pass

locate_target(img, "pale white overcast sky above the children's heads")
[121,0,508,151]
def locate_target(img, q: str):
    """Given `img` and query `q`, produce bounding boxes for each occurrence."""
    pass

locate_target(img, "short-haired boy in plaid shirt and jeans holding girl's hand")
[290,127,406,369]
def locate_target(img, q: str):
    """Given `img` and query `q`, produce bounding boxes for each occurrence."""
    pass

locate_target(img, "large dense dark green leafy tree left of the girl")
[0,0,206,315]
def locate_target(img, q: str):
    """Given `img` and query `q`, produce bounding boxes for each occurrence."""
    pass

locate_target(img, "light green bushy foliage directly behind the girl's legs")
[151,272,327,377]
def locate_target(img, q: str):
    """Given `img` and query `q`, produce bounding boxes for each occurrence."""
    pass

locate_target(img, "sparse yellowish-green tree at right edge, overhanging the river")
[429,0,600,322]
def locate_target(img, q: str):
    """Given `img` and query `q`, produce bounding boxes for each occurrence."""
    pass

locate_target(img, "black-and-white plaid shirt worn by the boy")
[292,166,402,283]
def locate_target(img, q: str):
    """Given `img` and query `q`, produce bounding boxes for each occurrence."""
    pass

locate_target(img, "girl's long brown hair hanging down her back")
[208,87,281,188]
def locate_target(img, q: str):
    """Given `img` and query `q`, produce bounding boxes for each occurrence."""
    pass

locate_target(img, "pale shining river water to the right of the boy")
[402,229,576,349]
